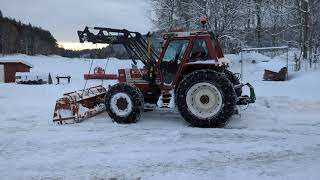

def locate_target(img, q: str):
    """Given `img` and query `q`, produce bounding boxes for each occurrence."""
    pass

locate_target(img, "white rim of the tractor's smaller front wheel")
[110,93,132,117]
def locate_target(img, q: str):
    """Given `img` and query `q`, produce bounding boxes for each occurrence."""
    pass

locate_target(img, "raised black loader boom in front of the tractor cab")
[78,27,158,68]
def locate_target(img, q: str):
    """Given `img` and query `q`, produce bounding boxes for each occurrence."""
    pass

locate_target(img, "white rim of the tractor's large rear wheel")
[186,83,223,119]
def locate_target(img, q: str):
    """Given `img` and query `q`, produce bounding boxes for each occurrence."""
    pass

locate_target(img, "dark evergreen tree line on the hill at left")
[0,10,128,59]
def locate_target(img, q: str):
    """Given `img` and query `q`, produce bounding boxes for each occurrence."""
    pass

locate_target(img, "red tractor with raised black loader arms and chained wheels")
[54,27,255,128]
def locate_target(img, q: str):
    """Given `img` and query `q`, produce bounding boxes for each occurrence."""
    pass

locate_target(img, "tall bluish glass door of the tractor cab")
[160,40,189,85]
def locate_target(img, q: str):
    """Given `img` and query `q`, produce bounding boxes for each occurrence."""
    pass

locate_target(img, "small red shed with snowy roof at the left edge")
[0,59,32,83]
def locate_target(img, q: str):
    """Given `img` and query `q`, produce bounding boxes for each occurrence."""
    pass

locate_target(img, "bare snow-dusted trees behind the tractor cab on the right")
[149,0,320,63]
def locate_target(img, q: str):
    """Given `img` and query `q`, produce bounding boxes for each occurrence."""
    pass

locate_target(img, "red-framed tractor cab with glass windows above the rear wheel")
[157,31,223,89]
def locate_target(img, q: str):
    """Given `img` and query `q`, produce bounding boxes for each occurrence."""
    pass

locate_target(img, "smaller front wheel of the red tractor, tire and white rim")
[105,83,144,124]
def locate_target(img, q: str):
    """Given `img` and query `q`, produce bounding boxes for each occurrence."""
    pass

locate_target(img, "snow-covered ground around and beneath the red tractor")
[0,54,320,180]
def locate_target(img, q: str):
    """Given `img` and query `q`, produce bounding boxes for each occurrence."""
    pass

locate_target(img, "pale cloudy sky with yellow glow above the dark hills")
[0,0,151,48]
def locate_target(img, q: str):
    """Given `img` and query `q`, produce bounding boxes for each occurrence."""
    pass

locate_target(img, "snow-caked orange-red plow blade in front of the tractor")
[53,86,107,125]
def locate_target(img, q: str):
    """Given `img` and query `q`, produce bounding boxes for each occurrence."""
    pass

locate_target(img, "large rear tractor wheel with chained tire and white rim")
[176,70,236,128]
